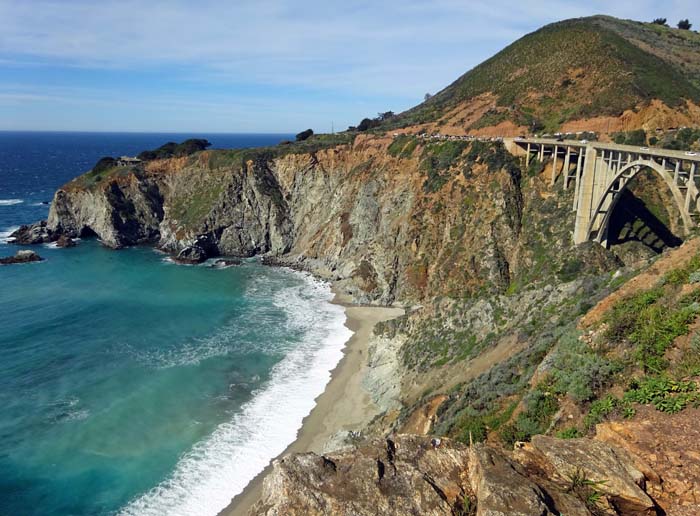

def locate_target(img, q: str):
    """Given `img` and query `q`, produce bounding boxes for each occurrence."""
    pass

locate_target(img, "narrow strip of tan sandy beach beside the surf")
[219,287,404,516]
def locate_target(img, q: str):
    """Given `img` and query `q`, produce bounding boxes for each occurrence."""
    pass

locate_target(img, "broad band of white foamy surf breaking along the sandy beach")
[120,278,352,516]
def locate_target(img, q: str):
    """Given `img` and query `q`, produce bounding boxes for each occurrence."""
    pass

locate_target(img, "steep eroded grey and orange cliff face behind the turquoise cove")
[32,137,612,304]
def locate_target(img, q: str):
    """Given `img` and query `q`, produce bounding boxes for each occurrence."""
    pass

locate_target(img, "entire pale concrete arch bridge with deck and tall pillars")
[506,138,700,246]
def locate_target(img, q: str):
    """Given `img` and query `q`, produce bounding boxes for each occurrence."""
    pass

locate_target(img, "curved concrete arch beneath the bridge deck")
[588,159,697,244]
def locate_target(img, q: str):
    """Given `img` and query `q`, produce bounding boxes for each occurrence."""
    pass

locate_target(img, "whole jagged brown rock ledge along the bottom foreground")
[250,435,657,516]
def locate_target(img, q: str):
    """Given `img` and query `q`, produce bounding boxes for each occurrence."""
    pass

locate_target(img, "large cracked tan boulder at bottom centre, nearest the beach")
[250,435,470,516]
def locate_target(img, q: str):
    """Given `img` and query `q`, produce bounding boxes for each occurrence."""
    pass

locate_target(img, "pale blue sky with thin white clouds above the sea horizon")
[0,0,700,133]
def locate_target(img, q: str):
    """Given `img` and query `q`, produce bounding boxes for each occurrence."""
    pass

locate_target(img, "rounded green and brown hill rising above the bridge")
[391,16,700,133]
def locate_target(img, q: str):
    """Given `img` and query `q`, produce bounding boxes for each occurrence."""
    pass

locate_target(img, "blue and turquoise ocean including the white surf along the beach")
[0,132,350,516]
